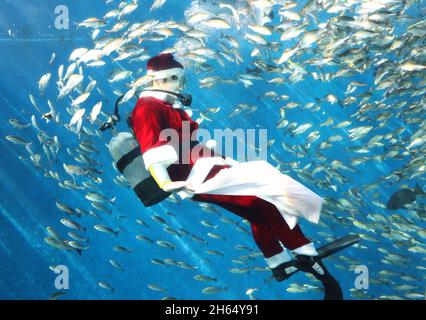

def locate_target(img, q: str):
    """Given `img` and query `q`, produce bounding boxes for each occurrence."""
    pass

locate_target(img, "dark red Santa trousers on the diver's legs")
[192,166,311,258]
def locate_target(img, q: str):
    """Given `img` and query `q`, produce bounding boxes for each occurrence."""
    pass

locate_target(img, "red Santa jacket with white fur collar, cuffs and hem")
[130,91,235,195]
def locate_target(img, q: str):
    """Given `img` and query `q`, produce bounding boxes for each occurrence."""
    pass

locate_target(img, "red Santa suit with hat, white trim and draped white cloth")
[130,54,342,298]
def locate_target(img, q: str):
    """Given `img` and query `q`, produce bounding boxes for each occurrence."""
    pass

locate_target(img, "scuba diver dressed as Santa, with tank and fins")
[105,53,353,300]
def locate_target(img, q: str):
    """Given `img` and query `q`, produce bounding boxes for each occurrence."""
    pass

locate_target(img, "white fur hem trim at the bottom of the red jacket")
[178,157,232,199]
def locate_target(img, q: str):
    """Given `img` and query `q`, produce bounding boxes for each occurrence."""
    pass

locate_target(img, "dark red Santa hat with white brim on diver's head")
[146,53,184,80]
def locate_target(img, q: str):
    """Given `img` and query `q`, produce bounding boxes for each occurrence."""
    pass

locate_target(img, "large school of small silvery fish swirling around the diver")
[5,0,426,299]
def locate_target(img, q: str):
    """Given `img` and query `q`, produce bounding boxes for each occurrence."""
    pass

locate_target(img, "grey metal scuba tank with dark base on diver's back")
[100,95,170,207]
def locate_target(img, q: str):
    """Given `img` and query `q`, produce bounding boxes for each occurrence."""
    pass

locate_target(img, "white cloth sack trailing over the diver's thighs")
[186,161,324,229]
